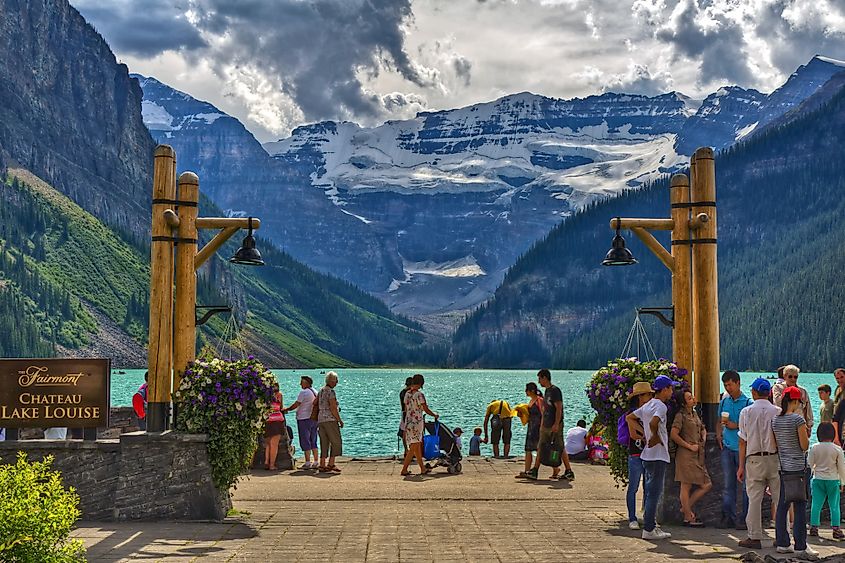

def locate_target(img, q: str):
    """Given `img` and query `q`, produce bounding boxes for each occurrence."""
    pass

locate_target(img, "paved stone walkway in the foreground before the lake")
[74,459,845,563]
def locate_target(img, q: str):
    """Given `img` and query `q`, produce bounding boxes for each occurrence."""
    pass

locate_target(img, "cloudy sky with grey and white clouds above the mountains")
[70,0,845,141]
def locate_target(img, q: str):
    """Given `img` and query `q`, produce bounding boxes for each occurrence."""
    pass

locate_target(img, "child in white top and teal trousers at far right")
[807,422,845,540]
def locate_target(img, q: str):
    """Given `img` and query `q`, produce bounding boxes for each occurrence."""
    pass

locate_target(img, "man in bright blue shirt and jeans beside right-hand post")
[716,369,754,530]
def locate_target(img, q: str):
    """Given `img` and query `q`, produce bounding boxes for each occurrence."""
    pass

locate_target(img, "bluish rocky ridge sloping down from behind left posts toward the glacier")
[133,75,401,294]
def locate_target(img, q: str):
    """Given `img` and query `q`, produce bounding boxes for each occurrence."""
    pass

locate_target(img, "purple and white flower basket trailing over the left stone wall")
[174,356,276,492]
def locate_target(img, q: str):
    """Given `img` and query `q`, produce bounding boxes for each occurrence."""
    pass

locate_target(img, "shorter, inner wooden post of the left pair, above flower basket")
[173,172,199,391]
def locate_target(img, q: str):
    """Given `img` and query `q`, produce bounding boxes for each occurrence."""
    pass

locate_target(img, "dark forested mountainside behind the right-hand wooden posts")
[452,81,845,371]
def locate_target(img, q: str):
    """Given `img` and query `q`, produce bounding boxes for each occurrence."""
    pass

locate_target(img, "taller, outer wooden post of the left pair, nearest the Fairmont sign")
[147,145,176,432]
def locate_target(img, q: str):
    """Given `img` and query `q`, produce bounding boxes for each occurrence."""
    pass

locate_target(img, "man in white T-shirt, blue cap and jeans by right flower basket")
[626,375,678,540]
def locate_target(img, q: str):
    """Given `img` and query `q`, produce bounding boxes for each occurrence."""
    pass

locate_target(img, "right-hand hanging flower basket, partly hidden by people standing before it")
[586,358,689,487]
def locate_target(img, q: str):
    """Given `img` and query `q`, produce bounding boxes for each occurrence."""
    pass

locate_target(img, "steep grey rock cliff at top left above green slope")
[0,0,155,240]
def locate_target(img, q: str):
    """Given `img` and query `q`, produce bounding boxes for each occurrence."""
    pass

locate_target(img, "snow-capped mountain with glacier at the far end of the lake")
[135,57,845,330]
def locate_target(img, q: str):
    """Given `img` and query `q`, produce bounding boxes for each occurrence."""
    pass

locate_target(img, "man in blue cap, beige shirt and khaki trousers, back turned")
[736,377,780,549]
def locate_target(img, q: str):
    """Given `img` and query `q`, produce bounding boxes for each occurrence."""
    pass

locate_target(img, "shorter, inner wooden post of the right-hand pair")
[669,174,693,387]
